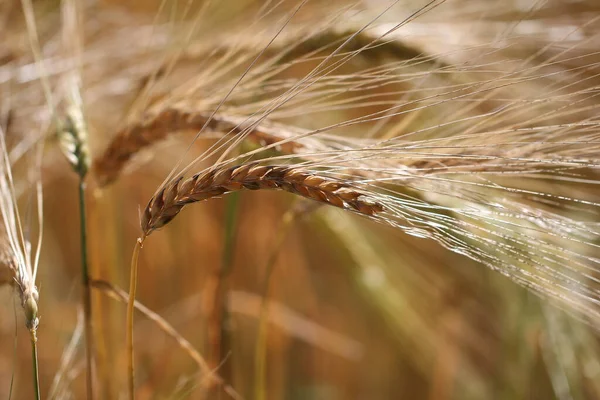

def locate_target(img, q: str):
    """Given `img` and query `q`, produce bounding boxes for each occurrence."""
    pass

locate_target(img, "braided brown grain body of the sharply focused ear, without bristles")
[141,163,384,236]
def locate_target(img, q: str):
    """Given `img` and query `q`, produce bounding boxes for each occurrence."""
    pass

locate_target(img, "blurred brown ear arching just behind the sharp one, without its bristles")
[94,107,304,186]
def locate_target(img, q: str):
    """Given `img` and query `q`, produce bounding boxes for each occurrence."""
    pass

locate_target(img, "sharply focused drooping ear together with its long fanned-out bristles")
[123,1,600,332]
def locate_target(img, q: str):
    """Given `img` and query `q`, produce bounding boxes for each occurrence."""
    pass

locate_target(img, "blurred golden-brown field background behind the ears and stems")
[0,0,600,400]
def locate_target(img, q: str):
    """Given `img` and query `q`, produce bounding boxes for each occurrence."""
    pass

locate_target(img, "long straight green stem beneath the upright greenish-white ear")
[79,180,94,399]
